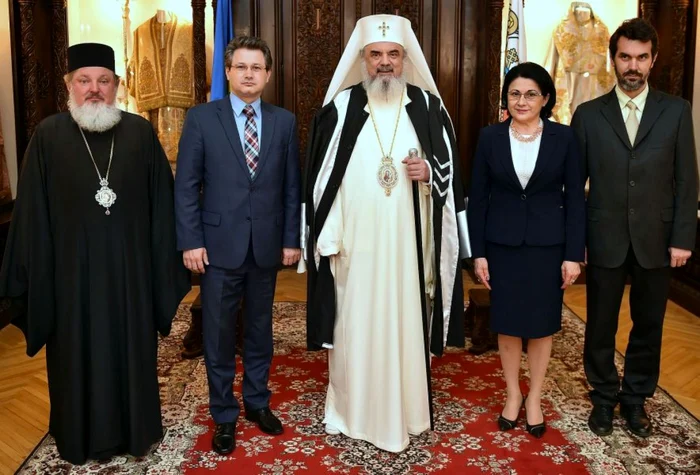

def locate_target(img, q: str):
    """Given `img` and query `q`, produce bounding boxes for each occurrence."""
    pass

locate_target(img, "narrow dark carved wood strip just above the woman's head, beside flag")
[486,0,503,124]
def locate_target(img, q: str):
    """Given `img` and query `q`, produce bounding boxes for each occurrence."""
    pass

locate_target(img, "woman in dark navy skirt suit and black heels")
[467,63,585,437]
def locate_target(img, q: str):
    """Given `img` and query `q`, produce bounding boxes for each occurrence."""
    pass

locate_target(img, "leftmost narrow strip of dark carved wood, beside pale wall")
[17,0,39,143]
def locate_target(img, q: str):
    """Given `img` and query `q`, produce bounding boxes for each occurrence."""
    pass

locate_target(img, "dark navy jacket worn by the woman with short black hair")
[467,120,585,262]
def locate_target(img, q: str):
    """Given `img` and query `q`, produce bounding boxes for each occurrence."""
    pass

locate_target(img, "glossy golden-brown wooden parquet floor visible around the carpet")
[0,270,700,475]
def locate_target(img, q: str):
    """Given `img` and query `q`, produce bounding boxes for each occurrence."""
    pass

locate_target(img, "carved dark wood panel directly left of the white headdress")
[295,2,342,150]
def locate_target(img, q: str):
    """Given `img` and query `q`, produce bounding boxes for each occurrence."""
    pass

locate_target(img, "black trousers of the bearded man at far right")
[583,245,671,405]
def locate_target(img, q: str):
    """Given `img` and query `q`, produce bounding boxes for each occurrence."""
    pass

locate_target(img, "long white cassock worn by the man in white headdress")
[317,91,434,452]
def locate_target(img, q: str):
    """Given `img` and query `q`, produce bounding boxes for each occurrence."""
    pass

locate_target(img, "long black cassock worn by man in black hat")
[0,113,190,464]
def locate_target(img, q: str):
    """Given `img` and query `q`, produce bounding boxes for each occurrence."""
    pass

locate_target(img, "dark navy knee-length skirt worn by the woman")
[486,242,564,338]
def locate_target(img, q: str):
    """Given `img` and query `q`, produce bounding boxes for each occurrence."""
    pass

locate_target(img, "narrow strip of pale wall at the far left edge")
[0,2,17,198]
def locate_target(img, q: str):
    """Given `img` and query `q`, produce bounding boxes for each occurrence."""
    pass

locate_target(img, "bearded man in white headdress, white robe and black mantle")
[300,15,469,452]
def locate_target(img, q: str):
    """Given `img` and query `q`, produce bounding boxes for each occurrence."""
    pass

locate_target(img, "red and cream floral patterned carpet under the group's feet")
[18,303,700,475]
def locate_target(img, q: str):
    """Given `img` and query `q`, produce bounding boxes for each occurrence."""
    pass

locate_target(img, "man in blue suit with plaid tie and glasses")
[175,37,301,455]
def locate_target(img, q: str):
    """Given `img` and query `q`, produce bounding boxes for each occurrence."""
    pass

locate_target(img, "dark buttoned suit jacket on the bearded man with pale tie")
[571,89,698,269]
